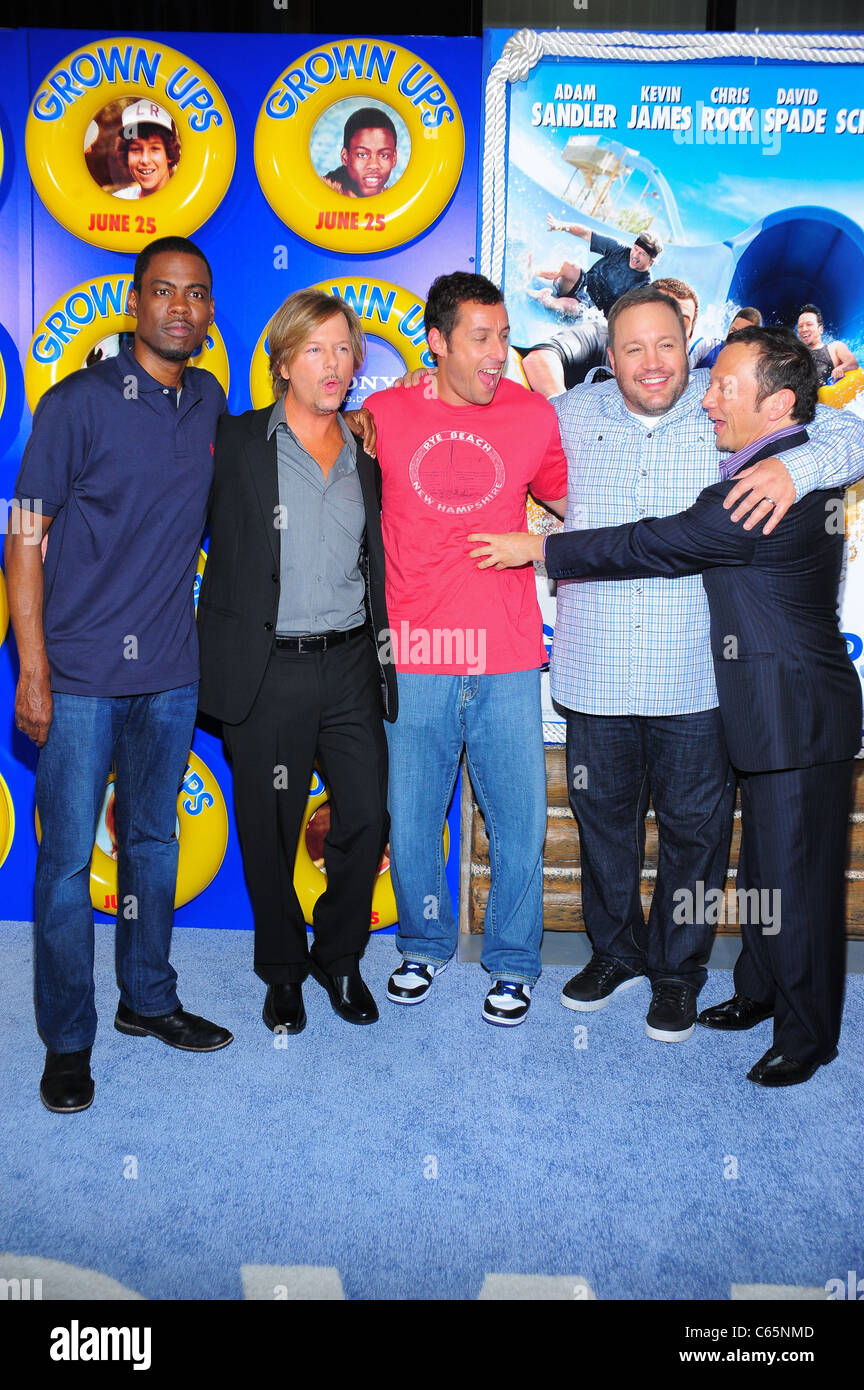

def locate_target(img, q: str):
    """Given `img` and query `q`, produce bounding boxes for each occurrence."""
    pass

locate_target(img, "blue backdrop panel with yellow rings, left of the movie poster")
[0,31,481,927]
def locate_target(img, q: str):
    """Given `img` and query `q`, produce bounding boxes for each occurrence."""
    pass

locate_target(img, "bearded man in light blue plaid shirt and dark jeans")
[551,286,864,1043]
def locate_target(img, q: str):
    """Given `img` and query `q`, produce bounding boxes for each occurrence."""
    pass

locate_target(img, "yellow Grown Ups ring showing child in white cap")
[25,38,236,252]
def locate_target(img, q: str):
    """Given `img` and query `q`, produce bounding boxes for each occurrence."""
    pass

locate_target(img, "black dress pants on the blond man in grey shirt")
[222,631,389,984]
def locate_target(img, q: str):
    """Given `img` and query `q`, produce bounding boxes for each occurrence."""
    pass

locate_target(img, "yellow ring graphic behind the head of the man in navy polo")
[24,272,229,410]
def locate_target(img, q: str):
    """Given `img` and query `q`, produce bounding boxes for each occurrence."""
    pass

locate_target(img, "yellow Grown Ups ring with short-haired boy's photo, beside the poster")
[254,39,465,256]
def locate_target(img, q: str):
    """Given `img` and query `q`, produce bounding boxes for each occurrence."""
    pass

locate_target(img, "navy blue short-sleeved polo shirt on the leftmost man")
[15,345,225,695]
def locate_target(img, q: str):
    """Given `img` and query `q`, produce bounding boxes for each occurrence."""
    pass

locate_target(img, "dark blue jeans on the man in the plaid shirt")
[567,708,735,990]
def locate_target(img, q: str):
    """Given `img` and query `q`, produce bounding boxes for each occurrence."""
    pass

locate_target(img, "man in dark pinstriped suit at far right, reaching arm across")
[470,328,861,1086]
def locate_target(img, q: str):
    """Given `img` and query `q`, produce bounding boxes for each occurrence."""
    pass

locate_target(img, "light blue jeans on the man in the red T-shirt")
[385,670,546,984]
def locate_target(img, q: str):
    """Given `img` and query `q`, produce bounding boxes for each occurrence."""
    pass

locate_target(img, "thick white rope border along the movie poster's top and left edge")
[481,29,864,285]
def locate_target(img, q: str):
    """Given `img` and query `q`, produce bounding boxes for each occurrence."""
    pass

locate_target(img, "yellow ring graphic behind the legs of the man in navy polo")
[36,752,228,915]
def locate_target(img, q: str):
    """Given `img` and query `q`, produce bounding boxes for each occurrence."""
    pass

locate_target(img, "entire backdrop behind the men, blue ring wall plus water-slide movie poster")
[0,31,864,927]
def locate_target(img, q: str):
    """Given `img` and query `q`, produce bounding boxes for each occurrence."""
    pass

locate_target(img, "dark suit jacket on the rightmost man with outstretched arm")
[546,430,861,771]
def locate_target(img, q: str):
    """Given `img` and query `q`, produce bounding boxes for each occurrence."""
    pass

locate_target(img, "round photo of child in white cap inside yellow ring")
[85,97,181,199]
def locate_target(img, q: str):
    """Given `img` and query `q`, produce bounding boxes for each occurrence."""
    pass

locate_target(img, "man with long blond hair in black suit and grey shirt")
[199,289,396,1033]
